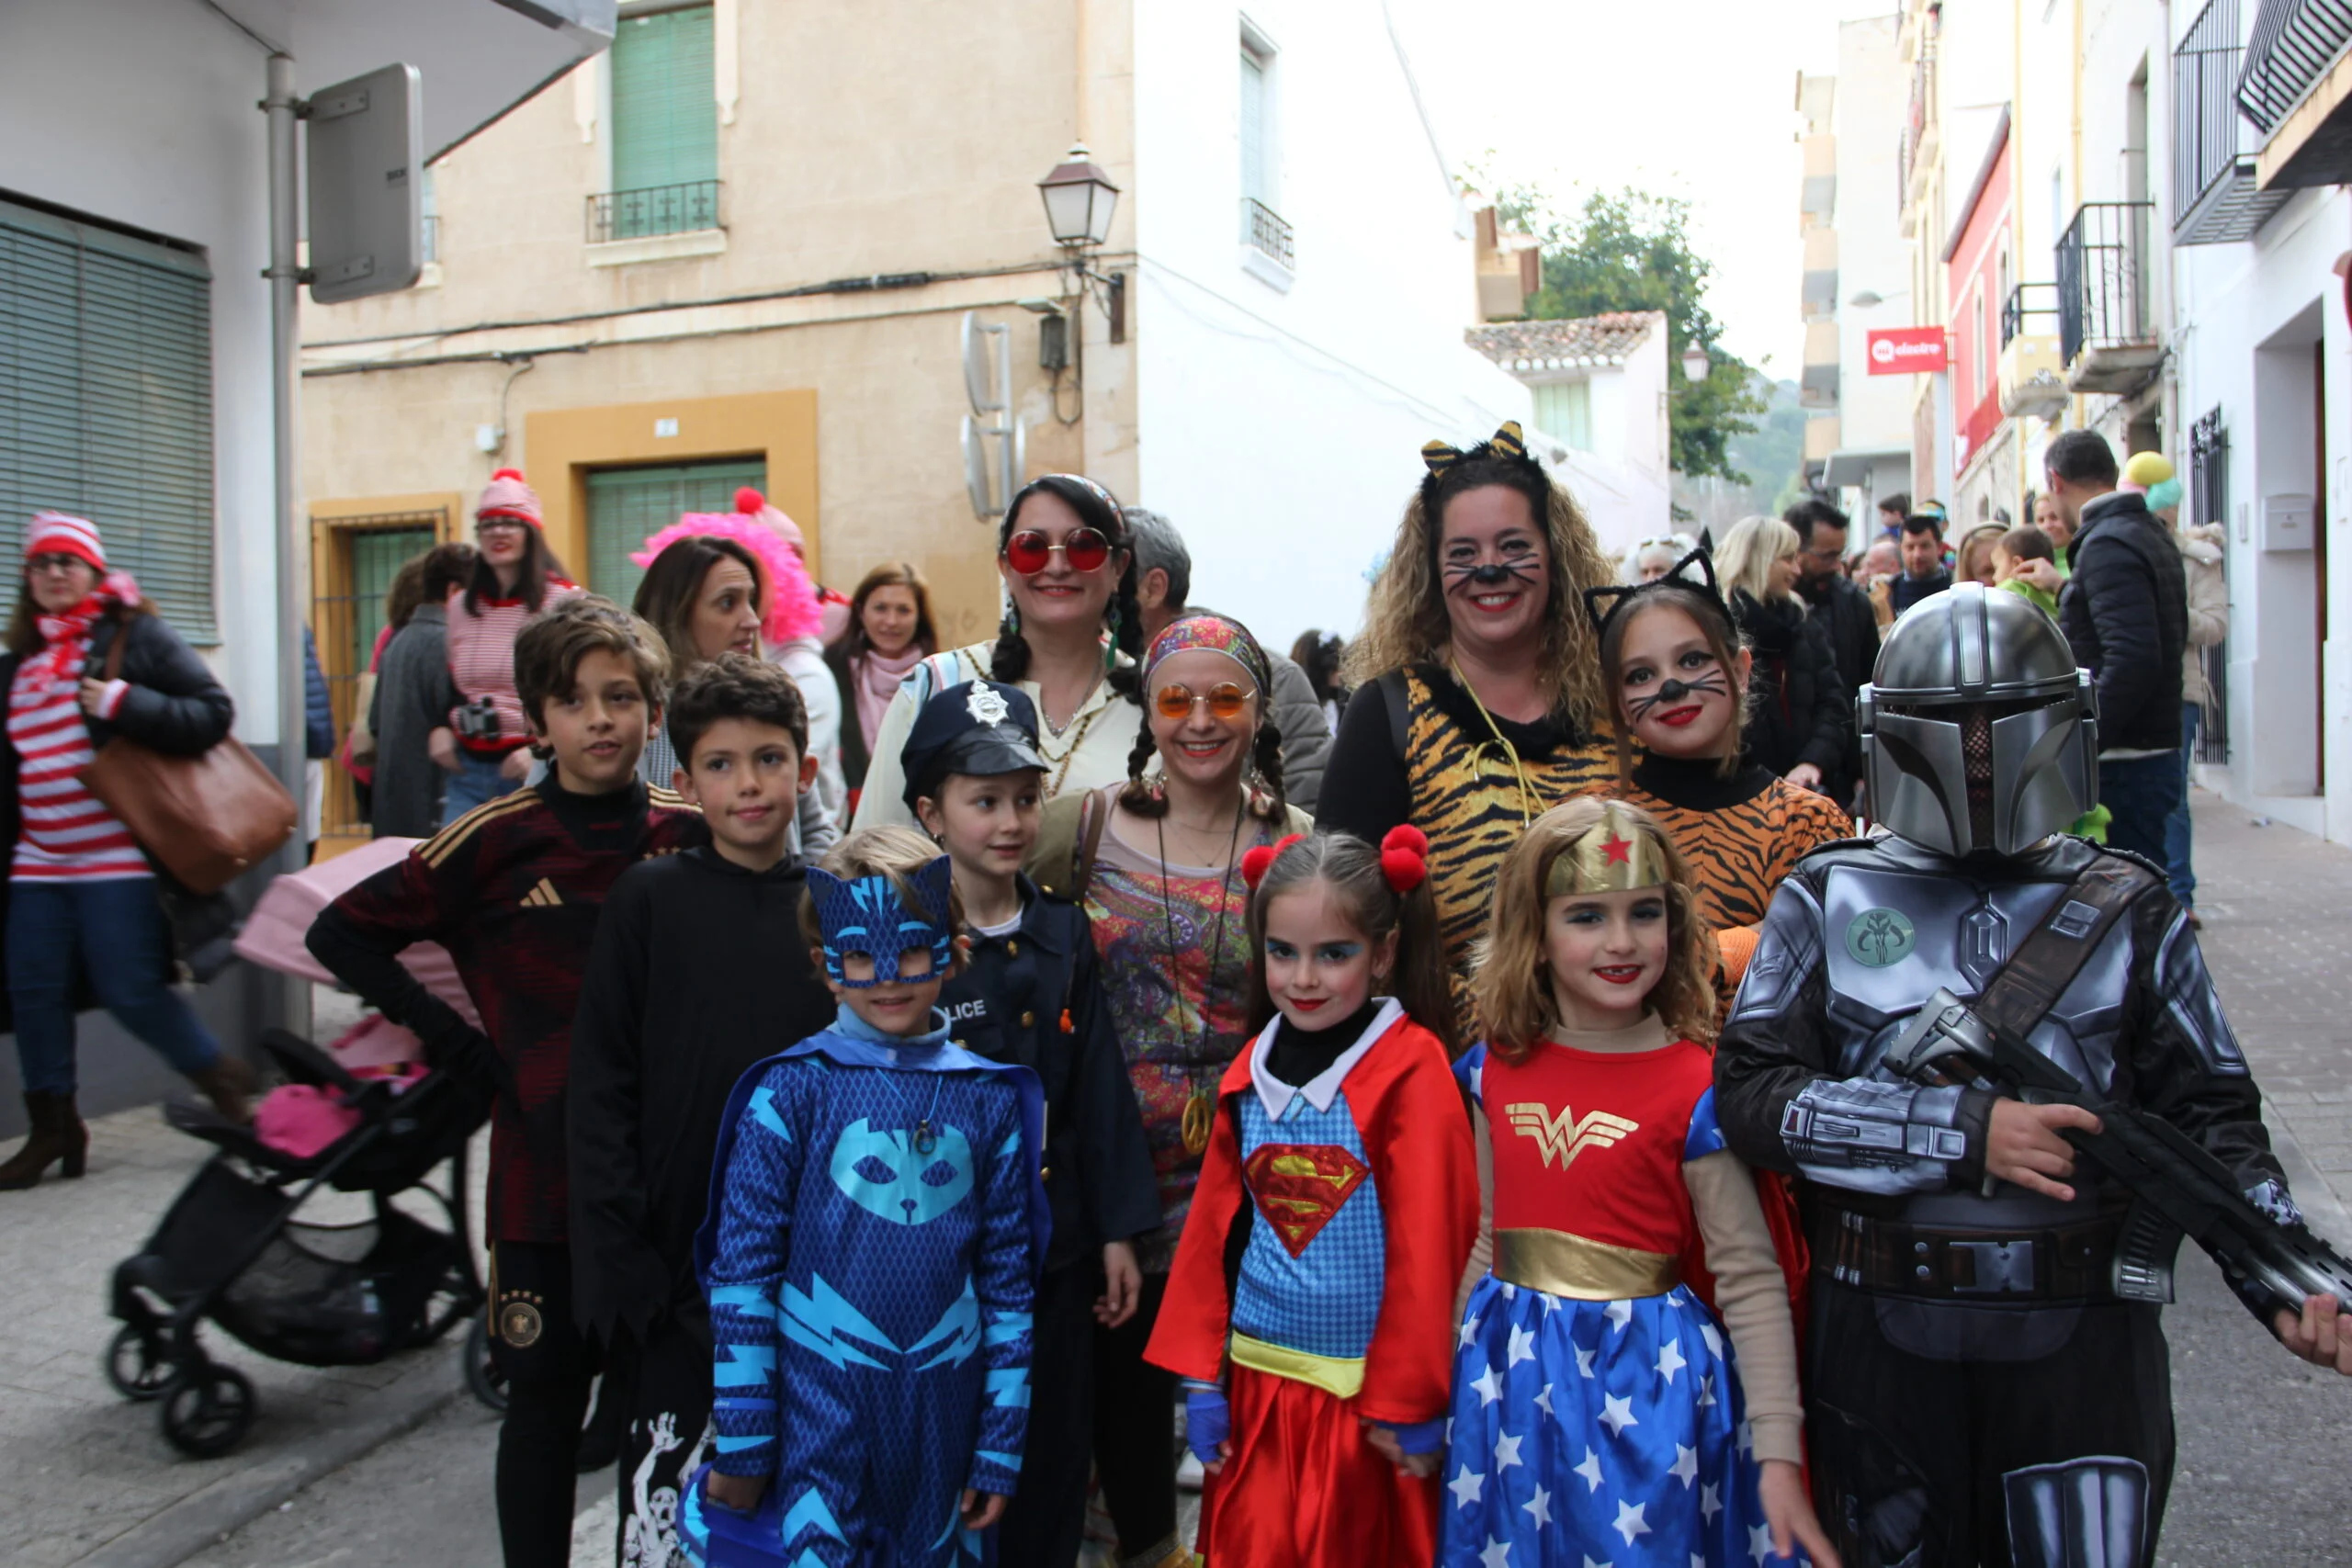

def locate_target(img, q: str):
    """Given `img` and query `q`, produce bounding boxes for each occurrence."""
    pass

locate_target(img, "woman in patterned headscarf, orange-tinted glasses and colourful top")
[1028,614,1315,1563]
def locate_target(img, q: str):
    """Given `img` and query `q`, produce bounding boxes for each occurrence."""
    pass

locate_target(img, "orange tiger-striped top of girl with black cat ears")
[1585,757,1853,931]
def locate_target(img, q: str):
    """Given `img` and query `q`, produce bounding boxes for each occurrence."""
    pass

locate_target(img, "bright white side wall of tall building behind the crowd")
[1131,0,1532,649]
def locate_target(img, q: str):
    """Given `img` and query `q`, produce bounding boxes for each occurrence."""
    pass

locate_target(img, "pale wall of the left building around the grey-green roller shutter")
[0,0,277,743]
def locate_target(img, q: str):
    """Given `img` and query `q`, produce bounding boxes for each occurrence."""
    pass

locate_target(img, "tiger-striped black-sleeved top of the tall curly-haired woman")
[1315,665,1616,1039]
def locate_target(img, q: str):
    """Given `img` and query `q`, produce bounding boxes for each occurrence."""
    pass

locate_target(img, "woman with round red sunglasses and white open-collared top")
[854,472,1143,828]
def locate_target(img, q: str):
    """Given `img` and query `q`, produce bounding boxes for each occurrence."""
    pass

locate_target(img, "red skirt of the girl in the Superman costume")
[1200,1366,1440,1568]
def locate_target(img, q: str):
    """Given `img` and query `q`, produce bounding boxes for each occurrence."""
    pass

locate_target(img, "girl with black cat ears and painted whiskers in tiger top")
[1585,550,1853,985]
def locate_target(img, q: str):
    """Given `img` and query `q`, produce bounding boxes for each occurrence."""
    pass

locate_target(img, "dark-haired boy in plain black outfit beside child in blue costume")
[570,656,832,1563]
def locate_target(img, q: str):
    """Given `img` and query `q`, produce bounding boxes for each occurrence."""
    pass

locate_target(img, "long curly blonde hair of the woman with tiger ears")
[1345,458,1616,736]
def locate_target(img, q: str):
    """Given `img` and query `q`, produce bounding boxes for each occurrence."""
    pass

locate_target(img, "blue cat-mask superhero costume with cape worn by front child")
[680,858,1049,1568]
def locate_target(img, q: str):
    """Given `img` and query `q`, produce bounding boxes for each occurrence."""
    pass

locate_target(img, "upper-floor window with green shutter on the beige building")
[595,5,719,240]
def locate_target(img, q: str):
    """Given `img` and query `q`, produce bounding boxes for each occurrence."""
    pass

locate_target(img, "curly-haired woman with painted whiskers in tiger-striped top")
[1317,425,1616,1039]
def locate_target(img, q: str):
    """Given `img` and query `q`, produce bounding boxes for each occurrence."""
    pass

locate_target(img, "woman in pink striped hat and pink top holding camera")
[425,468,579,828]
